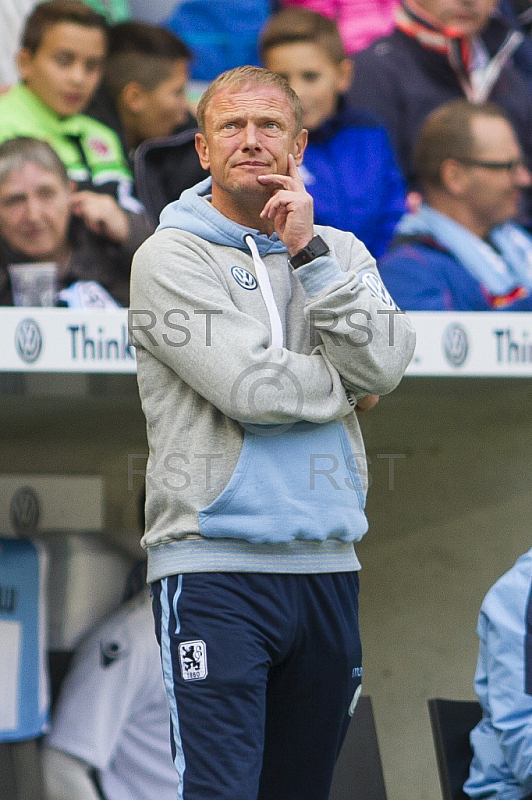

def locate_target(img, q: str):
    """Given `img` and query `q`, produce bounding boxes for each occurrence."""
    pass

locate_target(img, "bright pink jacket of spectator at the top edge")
[282,0,399,55]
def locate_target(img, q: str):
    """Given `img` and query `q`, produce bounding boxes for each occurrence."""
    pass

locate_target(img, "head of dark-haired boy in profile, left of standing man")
[87,22,196,158]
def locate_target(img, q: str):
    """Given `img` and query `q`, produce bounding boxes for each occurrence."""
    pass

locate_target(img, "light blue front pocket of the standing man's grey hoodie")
[198,422,368,544]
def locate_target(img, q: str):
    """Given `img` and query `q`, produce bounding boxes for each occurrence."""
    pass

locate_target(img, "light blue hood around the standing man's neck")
[157,177,286,256]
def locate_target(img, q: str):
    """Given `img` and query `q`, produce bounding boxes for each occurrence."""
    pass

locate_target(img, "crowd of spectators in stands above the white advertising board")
[0,0,532,310]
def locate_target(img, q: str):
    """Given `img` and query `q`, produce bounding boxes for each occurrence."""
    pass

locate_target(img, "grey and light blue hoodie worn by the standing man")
[130,178,415,581]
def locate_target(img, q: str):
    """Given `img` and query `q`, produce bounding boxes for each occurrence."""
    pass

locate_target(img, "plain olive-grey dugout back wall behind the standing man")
[0,375,532,800]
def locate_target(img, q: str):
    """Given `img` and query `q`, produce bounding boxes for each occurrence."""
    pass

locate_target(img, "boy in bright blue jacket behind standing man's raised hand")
[260,8,405,256]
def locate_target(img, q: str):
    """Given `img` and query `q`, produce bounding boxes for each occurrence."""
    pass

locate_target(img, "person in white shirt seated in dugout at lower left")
[43,578,178,800]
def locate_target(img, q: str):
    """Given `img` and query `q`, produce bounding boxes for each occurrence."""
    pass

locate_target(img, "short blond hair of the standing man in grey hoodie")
[196,66,303,136]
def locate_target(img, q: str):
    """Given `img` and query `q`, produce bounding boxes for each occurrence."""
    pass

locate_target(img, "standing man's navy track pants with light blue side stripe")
[152,572,362,800]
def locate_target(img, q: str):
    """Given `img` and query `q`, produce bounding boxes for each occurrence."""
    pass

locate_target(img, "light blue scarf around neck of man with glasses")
[395,204,532,297]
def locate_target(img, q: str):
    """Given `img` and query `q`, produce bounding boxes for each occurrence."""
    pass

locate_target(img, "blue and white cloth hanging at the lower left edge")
[0,538,49,742]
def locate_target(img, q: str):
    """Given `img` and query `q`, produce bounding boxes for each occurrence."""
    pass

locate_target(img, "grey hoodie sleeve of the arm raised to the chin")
[296,229,416,396]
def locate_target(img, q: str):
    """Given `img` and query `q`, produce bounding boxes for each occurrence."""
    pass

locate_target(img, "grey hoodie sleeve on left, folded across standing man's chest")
[129,233,352,424]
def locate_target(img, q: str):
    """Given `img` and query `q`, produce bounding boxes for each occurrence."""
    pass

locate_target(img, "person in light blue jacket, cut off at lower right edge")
[464,550,532,800]
